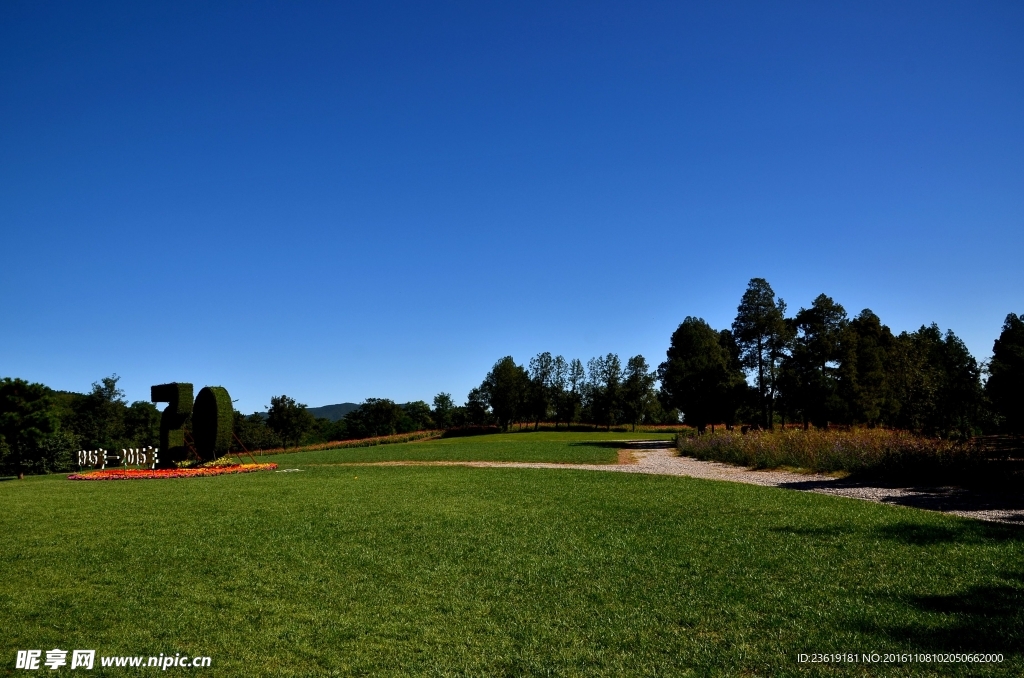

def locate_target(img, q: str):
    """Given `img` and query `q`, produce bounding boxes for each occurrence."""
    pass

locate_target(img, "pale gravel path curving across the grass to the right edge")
[327,448,1024,524]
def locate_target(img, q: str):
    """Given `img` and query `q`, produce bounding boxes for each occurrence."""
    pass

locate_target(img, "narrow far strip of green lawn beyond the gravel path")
[260,431,674,466]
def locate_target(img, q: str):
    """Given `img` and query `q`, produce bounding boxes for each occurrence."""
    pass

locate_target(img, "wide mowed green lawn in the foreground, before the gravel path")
[0,432,1024,676]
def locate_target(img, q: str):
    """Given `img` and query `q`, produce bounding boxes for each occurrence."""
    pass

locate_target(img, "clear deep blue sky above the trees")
[0,1,1024,412]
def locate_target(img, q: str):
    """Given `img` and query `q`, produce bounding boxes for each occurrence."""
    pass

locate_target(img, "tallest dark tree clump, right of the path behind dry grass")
[658,278,1024,436]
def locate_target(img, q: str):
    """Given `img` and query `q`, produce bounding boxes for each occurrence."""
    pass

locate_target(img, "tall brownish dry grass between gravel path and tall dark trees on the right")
[676,428,983,475]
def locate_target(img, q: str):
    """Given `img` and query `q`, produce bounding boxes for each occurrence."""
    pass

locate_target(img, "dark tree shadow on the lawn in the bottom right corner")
[858,573,1024,654]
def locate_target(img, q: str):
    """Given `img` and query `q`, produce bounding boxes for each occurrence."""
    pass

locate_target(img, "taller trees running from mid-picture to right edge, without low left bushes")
[435,278,1024,438]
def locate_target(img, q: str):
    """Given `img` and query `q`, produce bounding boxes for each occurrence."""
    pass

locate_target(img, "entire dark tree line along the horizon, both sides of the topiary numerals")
[0,278,1024,473]
